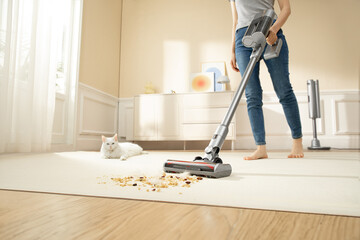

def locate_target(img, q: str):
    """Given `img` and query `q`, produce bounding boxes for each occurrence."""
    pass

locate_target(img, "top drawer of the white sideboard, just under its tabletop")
[183,92,233,108]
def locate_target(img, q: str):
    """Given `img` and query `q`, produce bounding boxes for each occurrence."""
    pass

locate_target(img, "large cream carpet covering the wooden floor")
[0,151,360,216]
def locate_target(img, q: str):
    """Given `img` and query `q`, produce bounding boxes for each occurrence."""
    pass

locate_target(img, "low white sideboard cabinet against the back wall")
[134,91,236,141]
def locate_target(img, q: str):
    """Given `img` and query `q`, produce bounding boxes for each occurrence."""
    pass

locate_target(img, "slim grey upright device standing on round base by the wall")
[307,79,330,150]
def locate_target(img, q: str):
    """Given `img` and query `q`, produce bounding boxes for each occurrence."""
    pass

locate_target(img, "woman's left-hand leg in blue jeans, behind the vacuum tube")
[235,28,267,160]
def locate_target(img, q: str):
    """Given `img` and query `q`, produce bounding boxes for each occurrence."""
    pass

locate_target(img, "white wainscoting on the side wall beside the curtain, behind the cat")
[76,83,118,150]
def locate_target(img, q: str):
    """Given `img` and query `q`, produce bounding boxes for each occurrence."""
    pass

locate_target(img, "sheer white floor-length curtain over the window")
[0,0,61,153]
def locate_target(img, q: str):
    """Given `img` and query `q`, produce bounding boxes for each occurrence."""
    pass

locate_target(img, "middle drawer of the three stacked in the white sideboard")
[183,108,234,124]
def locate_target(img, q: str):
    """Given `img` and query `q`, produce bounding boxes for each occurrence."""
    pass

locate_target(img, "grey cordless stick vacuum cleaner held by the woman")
[164,9,282,178]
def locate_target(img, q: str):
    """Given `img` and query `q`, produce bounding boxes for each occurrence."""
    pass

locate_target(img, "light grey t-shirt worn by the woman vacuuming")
[230,0,274,29]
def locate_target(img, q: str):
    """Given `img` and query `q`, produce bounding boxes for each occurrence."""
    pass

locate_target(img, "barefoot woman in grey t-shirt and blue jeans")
[230,0,304,160]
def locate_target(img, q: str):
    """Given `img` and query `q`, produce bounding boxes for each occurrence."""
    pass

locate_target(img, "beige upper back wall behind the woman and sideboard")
[119,0,360,98]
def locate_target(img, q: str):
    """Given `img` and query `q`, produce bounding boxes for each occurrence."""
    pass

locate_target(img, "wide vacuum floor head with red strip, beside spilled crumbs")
[164,159,232,178]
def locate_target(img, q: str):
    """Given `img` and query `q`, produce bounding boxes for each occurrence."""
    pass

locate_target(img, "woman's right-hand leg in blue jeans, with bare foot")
[265,30,304,157]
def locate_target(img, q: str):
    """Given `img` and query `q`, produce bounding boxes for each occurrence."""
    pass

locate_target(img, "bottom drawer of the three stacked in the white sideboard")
[183,123,236,140]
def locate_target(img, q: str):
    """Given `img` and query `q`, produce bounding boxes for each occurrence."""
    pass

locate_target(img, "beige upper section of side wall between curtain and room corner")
[79,0,122,97]
